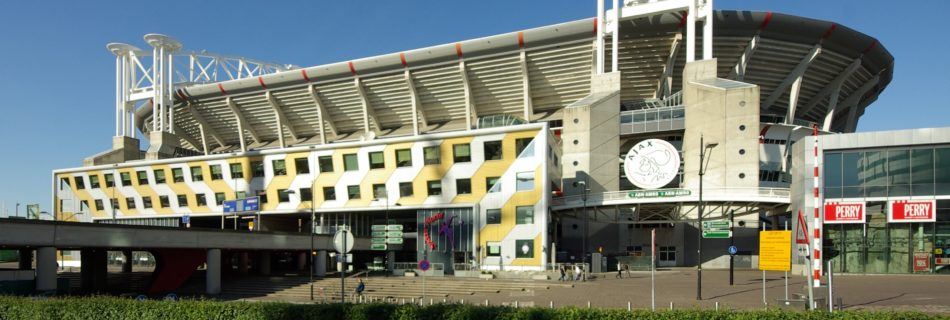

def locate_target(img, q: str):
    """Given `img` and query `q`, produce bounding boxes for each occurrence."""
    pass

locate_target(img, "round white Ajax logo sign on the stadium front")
[623,139,680,189]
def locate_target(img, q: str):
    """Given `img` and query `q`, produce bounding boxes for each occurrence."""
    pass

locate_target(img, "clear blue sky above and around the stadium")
[0,0,950,215]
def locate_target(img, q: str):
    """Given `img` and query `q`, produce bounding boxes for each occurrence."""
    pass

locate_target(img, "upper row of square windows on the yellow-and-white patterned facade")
[62,138,532,190]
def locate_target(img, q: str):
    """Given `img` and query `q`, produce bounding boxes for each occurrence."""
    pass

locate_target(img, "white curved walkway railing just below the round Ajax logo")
[551,187,791,206]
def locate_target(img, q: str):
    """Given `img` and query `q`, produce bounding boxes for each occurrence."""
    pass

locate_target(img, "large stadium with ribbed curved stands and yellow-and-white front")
[52,0,893,274]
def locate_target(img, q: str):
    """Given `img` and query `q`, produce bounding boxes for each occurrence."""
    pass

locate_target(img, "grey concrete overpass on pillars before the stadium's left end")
[0,219,370,294]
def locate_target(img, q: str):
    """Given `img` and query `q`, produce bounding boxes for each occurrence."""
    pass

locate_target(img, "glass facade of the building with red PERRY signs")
[823,146,950,274]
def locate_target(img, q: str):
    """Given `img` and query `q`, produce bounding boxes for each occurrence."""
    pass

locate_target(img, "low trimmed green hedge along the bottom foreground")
[0,297,950,320]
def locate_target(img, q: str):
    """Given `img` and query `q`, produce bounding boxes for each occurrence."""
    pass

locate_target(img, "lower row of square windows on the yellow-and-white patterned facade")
[77,172,534,212]
